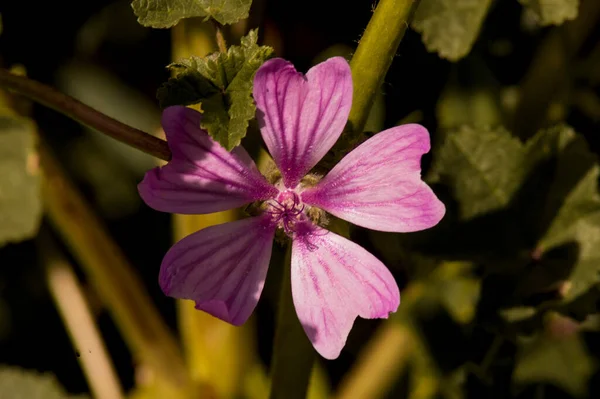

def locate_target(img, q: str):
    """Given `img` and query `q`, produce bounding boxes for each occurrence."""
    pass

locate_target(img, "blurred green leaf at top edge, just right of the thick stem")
[412,0,491,61]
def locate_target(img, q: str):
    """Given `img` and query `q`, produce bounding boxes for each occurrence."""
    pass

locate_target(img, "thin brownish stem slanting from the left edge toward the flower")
[0,69,171,161]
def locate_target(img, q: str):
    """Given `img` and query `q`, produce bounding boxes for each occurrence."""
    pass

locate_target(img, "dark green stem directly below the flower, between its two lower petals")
[270,244,315,399]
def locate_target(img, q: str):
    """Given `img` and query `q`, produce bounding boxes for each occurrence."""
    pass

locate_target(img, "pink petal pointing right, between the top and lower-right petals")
[302,124,446,232]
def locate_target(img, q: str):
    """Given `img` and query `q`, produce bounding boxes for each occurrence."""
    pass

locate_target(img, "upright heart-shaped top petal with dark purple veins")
[254,57,352,188]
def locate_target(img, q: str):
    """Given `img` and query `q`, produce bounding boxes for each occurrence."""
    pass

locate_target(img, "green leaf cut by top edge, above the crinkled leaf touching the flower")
[131,0,252,28]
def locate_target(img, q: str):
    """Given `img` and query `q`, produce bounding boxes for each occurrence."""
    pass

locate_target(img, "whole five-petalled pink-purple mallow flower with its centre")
[139,57,445,359]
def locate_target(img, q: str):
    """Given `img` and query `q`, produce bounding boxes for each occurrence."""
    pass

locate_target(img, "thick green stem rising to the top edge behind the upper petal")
[348,0,419,135]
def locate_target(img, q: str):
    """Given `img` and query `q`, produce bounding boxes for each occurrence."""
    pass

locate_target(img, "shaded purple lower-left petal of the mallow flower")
[159,216,275,326]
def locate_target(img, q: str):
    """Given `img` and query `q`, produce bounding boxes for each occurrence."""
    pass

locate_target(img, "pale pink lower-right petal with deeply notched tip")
[292,224,400,359]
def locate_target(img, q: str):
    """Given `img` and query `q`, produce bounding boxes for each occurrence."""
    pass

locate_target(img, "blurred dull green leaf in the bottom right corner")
[513,334,595,397]
